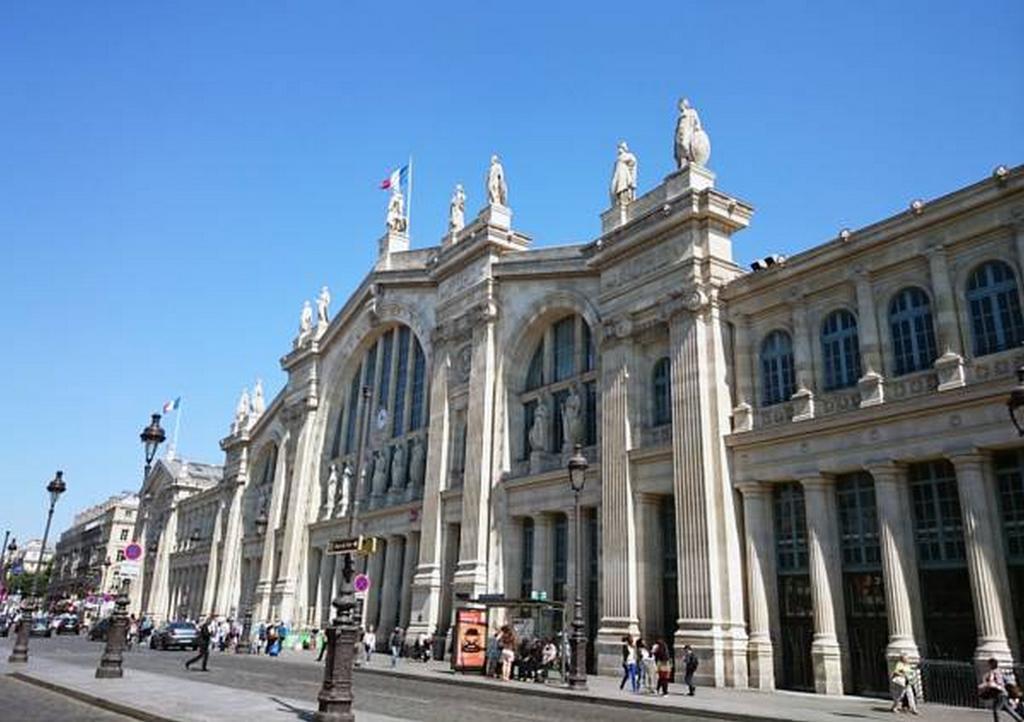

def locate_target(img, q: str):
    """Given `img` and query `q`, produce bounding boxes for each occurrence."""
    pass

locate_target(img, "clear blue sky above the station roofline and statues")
[0,0,1024,539]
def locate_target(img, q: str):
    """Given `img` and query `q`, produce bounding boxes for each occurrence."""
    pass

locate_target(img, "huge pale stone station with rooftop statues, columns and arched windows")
[128,107,1024,693]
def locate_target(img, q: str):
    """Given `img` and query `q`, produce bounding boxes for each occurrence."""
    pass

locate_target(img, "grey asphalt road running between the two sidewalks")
[12,637,724,722]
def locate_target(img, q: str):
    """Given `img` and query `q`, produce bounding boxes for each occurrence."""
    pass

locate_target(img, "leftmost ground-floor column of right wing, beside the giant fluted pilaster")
[737,481,779,689]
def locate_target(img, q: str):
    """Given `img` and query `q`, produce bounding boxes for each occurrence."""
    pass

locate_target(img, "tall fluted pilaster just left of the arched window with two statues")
[455,314,495,597]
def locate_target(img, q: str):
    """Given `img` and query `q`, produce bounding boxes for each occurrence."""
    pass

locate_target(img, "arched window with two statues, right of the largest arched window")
[519,314,597,459]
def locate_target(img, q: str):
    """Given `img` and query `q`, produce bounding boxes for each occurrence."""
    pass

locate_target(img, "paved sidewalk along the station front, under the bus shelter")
[270,651,992,722]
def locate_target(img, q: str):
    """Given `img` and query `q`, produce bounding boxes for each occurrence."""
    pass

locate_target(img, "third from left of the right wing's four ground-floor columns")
[868,464,924,662]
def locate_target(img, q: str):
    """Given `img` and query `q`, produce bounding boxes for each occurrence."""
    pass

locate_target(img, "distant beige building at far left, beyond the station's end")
[49,492,138,596]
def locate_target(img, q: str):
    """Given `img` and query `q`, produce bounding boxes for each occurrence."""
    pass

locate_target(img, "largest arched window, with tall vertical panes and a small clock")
[331,325,428,502]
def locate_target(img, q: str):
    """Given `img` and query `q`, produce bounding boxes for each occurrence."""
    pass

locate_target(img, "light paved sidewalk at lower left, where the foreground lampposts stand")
[4,659,400,722]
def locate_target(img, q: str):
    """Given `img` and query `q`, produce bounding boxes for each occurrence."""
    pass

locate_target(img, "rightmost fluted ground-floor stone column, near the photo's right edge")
[950,454,1013,674]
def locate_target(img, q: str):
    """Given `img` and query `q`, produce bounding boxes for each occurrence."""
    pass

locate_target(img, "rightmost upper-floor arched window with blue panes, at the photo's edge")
[967,261,1024,356]
